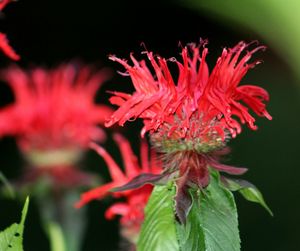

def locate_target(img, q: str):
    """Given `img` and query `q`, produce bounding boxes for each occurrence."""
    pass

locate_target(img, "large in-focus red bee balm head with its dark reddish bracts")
[106,41,272,224]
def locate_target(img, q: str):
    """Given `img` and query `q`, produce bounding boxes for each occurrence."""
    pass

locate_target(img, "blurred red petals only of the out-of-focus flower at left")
[0,64,111,154]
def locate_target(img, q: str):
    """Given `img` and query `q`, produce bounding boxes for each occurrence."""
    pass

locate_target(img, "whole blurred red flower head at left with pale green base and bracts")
[0,63,112,188]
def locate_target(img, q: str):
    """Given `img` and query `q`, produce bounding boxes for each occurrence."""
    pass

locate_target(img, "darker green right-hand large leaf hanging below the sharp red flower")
[177,172,240,251]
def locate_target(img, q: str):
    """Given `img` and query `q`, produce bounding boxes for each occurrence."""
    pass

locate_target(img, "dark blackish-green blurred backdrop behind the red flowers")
[0,0,300,251]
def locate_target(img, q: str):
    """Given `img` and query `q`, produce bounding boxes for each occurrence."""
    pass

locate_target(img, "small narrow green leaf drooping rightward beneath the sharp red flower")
[224,178,273,216]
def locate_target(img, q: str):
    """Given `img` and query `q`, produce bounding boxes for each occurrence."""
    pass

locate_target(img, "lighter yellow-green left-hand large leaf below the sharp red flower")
[137,182,179,251]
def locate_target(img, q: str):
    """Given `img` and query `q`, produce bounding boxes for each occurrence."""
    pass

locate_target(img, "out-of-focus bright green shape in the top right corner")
[180,0,300,83]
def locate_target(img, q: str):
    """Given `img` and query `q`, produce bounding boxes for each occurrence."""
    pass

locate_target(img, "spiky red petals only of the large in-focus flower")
[106,42,271,142]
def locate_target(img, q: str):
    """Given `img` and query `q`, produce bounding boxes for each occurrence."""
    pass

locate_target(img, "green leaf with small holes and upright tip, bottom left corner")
[0,197,29,251]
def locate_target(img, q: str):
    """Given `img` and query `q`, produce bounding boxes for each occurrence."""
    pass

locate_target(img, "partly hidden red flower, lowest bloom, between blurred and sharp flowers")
[76,134,162,242]
